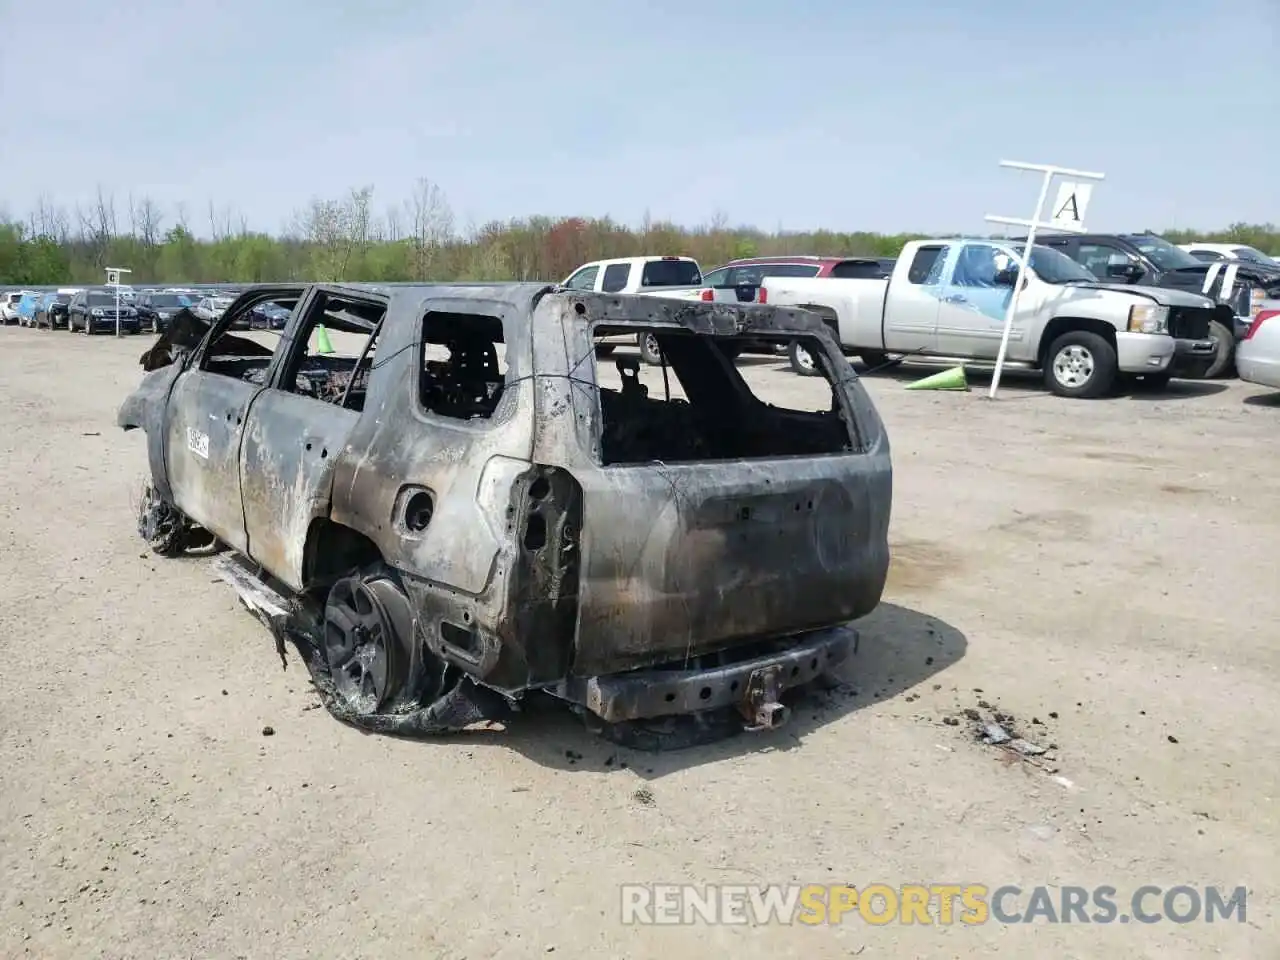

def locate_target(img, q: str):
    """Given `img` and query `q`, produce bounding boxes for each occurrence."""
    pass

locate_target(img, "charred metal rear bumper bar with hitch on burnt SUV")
[552,626,858,723]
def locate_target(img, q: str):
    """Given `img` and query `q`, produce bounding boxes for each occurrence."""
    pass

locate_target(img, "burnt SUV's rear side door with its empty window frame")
[236,284,390,590]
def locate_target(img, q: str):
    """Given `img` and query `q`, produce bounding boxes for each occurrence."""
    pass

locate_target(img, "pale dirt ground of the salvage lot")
[0,328,1280,960]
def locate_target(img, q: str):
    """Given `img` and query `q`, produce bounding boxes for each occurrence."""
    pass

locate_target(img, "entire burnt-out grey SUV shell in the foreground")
[118,284,892,742]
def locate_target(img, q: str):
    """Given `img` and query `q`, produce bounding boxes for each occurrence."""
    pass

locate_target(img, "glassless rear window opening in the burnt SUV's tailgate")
[594,326,858,466]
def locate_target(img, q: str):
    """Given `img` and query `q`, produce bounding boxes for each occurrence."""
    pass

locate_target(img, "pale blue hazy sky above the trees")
[0,0,1280,239]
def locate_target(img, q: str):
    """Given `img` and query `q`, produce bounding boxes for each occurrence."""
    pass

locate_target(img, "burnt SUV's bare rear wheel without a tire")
[324,568,413,714]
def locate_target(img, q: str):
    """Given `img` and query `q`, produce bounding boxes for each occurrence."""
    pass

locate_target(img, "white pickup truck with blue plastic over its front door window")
[765,239,1217,398]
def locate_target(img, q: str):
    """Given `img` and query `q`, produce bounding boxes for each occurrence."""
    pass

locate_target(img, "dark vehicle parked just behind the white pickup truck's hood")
[1043,233,1280,378]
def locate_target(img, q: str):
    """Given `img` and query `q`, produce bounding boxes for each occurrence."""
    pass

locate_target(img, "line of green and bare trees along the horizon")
[0,178,1280,285]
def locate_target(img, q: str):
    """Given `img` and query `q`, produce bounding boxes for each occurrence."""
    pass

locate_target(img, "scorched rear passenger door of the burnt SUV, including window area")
[239,287,387,590]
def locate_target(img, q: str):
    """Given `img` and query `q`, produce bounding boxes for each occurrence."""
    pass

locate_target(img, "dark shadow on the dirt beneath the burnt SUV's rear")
[424,603,968,778]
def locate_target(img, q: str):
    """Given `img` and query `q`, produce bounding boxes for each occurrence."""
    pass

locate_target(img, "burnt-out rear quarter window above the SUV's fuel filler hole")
[419,310,507,420]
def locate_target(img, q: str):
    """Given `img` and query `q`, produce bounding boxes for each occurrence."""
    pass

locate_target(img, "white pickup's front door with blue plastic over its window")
[937,243,1027,360]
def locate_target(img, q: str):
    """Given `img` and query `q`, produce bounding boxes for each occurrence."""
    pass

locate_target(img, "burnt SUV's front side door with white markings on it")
[164,296,274,553]
